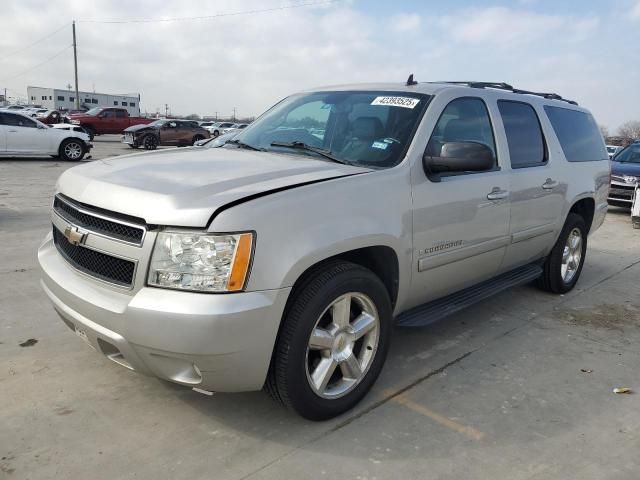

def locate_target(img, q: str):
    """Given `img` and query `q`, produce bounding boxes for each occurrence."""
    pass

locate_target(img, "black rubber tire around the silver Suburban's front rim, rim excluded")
[284,266,392,420]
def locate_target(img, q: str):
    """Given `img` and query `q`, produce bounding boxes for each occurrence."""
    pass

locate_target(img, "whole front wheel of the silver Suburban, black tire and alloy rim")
[265,262,392,420]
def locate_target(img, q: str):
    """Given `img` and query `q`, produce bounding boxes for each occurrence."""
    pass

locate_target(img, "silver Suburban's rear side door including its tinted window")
[498,100,567,271]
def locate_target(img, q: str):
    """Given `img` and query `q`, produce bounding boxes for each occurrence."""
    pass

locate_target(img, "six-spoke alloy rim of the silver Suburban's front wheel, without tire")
[306,292,380,399]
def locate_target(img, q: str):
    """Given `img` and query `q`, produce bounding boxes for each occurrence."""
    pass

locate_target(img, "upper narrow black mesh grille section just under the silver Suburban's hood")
[53,196,145,245]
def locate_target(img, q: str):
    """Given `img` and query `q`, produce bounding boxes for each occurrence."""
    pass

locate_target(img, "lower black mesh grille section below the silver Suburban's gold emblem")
[53,226,136,287]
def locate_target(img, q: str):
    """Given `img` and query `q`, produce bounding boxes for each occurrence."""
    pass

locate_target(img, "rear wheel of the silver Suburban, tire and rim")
[537,213,587,293]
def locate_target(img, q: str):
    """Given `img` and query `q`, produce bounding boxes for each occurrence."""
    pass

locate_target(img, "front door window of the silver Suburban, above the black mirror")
[427,97,496,168]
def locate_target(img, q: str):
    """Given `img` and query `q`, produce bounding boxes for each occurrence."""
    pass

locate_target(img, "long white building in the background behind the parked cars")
[27,87,140,116]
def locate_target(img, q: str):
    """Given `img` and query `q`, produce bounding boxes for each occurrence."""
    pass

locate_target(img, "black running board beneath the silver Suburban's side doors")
[396,264,542,327]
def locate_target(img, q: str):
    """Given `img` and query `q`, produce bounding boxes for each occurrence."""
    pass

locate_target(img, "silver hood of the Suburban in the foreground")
[58,148,371,227]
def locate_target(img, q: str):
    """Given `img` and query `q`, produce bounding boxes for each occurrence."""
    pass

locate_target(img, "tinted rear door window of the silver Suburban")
[498,100,547,168]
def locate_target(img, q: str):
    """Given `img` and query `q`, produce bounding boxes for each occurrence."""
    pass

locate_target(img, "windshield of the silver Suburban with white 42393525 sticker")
[236,91,430,168]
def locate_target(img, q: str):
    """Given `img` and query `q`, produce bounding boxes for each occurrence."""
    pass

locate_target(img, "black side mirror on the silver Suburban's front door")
[422,142,495,181]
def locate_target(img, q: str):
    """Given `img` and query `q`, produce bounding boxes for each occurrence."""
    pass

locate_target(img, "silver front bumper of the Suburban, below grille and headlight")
[38,234,290,392]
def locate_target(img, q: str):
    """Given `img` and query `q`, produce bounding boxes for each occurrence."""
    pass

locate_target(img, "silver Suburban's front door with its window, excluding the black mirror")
[411,96,510,306]
